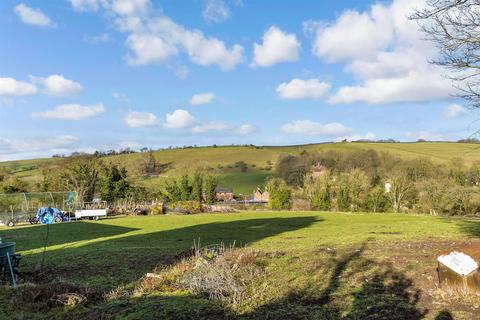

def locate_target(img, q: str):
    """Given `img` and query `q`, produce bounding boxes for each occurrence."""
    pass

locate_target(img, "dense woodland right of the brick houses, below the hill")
[273,150,480,215]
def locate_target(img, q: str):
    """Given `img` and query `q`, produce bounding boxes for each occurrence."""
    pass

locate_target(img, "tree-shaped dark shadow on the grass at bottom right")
[240,243,426,320]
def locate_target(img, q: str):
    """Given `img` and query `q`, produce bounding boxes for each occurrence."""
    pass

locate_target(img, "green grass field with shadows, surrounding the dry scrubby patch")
[0,212,480,319]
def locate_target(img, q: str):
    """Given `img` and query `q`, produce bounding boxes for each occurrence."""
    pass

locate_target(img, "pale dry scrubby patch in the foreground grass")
[133,245,268,308]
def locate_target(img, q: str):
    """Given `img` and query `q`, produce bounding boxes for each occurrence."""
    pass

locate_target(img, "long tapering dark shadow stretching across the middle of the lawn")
[22,217,319,291]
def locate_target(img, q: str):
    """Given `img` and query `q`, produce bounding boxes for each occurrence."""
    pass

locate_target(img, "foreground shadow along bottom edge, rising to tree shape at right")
[72,244,424,320]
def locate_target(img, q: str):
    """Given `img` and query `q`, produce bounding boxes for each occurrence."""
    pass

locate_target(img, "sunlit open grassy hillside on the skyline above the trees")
[0,142,480,193]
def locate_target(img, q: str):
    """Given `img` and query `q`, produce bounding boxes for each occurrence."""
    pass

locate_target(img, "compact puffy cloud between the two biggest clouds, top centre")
[251,26,300,67]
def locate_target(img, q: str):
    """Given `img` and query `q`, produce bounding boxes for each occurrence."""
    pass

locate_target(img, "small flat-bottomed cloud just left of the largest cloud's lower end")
[277,78,330,99]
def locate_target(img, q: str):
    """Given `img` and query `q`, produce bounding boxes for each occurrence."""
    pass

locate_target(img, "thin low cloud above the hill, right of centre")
[281,120,352,136]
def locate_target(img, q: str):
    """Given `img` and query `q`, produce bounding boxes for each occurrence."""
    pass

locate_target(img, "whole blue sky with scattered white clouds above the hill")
[0,0,476,160]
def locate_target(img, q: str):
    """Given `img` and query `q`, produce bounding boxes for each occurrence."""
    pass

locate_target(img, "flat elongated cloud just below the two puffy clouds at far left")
[32,103,105,120]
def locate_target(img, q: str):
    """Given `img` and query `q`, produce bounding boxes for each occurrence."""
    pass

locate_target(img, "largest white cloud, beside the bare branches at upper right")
[304,0,455,104]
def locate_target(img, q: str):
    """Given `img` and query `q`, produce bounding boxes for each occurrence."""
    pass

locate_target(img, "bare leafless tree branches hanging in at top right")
[411,0,480,108]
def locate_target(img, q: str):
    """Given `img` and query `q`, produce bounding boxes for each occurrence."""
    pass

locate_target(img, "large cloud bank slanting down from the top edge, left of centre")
[71,0,244,71]
